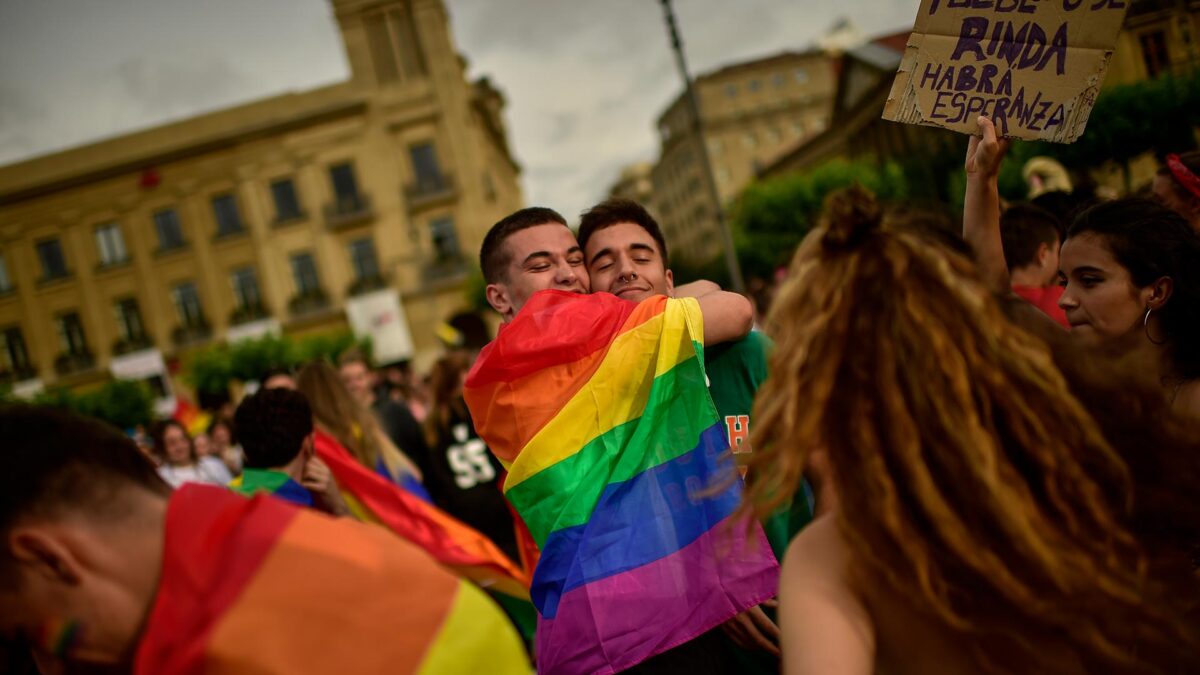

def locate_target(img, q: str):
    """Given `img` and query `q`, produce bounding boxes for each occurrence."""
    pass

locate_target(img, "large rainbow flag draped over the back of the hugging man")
[466,291,779,673]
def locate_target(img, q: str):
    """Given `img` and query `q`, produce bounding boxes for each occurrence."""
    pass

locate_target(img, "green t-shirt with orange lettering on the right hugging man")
[704,330,812,560]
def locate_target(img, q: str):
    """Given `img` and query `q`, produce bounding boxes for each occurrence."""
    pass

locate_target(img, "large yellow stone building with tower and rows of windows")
[0,0,522,393]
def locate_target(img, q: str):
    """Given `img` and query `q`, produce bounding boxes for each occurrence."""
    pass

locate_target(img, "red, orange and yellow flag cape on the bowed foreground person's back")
[133,484,530,675]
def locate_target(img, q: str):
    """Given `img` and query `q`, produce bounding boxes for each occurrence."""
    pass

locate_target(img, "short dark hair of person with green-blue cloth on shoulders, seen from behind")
[234,389,312,468]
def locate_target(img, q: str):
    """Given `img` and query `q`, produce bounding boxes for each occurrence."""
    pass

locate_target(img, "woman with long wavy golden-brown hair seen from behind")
[746,189,1200,674]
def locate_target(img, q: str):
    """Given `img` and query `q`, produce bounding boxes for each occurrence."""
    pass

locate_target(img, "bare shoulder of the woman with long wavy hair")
[779,514,875,675]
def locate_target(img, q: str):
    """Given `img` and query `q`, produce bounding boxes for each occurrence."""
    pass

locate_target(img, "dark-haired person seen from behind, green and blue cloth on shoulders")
[229,388,349,515]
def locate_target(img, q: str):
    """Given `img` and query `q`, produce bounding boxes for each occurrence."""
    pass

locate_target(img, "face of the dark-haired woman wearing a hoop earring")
[1058,233,1153,345]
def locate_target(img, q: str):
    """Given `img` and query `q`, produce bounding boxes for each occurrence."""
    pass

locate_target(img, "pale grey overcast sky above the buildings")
[0,0,919,221]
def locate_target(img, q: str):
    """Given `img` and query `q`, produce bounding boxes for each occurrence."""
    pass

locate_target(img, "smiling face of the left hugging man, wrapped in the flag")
[487,222,589,321]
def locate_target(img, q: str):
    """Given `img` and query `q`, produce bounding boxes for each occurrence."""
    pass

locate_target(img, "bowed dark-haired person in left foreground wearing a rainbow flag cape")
[0,406,529,674]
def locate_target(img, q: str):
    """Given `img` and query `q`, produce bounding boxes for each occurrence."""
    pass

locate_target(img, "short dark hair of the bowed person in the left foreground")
[0,405,170,581]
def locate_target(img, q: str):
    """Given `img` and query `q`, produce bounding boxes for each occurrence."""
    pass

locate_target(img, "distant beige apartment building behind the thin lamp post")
[652,50,836,263]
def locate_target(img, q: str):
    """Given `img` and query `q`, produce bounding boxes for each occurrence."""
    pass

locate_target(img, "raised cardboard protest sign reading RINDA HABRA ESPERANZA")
[883,0,1130,143]
